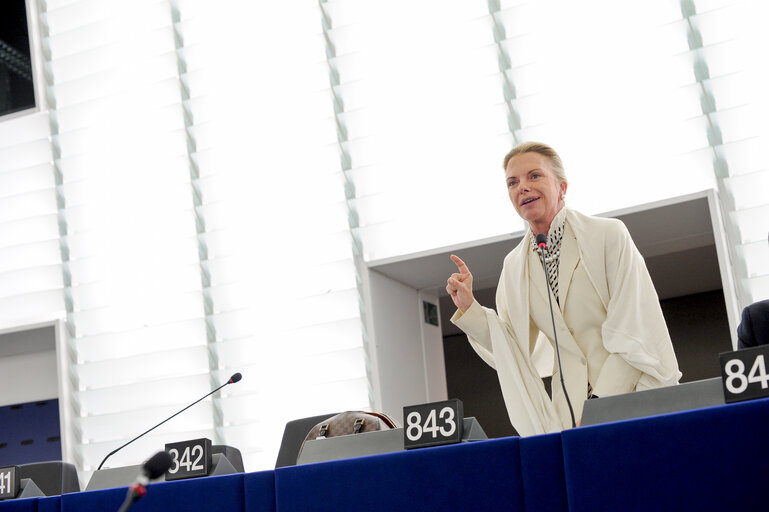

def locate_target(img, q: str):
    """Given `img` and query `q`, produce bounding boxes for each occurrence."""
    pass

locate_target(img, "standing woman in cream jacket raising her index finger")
[446,142,681,436]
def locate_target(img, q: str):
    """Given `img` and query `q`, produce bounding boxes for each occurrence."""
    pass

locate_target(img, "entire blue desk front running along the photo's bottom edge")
[6,399,769,512]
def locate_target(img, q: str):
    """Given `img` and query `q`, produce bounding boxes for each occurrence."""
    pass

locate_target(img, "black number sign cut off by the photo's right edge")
[720,345,769,403]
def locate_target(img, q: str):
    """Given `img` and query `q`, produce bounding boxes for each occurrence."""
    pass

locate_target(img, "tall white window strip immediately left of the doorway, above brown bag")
[178,0,370,470]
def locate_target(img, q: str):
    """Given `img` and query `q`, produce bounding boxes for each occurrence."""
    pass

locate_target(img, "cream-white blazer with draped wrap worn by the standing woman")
[452,209,681,436]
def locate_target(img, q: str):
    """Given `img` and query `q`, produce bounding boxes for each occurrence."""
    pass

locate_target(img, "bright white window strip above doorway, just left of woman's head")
[327,0,516,262]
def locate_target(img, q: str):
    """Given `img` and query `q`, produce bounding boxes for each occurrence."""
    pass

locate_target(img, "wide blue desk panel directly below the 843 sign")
[275,438,524,512]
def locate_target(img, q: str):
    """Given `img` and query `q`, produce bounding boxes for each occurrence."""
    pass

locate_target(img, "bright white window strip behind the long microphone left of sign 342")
[41,0,216,469]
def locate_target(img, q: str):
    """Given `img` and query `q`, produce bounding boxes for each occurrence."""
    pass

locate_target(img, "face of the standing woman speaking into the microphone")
[505,152,566,234]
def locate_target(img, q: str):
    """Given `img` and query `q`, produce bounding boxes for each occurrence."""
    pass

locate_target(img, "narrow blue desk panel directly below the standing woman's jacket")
[521,433,569,512]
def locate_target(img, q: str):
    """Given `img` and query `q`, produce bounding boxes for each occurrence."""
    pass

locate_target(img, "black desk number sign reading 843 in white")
[403,399,464,450]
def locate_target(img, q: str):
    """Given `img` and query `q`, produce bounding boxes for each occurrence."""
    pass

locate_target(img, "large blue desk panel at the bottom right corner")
[562,399,769,512]
